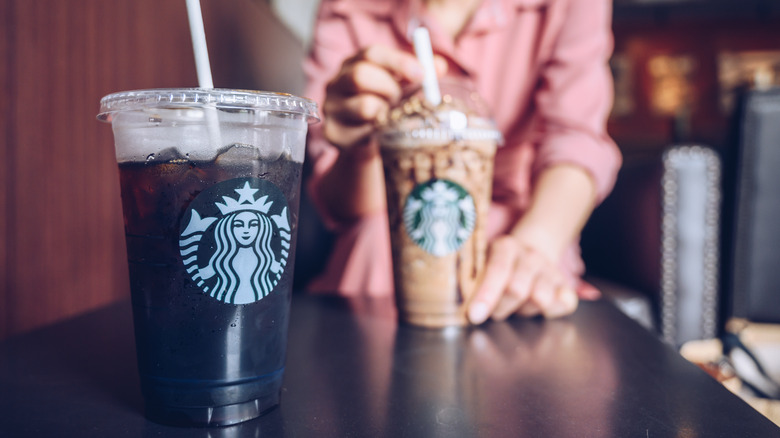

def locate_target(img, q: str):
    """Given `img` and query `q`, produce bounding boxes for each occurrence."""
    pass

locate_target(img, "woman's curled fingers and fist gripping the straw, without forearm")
[322,46,423,151]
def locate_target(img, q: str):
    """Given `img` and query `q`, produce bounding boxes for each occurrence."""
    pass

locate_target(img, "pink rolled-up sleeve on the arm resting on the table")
[533,0,622,202]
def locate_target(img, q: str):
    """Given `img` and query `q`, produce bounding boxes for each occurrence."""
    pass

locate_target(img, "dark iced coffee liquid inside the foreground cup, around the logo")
[119,148,302,424]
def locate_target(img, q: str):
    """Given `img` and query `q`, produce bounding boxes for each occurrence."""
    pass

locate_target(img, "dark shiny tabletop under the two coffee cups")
[0,295,780,438]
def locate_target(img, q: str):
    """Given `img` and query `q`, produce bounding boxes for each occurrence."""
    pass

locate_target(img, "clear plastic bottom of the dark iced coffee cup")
[145,393,280,427]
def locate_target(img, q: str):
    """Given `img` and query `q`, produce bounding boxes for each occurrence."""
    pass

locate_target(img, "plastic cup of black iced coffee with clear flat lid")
[99,89,317,425]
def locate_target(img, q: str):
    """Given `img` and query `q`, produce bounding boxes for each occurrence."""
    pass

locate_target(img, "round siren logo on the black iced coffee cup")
[179,178,291,304]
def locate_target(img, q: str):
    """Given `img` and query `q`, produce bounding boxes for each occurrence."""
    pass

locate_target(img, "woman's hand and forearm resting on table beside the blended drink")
[468,164,595,324]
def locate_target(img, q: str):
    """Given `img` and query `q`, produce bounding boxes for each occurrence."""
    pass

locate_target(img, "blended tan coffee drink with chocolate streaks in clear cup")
[379,85,501,327]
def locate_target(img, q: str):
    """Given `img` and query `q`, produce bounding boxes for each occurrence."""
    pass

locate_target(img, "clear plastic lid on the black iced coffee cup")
[98,88,320,123]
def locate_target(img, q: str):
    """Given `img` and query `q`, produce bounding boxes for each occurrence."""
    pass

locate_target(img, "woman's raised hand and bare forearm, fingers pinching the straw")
[317,46,447,221]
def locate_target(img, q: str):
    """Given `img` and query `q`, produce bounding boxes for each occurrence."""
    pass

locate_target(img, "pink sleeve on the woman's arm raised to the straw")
[304,0,357,230]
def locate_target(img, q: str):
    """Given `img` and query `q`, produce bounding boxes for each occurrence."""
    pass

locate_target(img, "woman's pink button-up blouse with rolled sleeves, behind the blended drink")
[305,0,621,296]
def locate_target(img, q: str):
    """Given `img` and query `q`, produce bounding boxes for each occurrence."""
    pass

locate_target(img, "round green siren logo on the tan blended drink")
[403,179,476,257]
